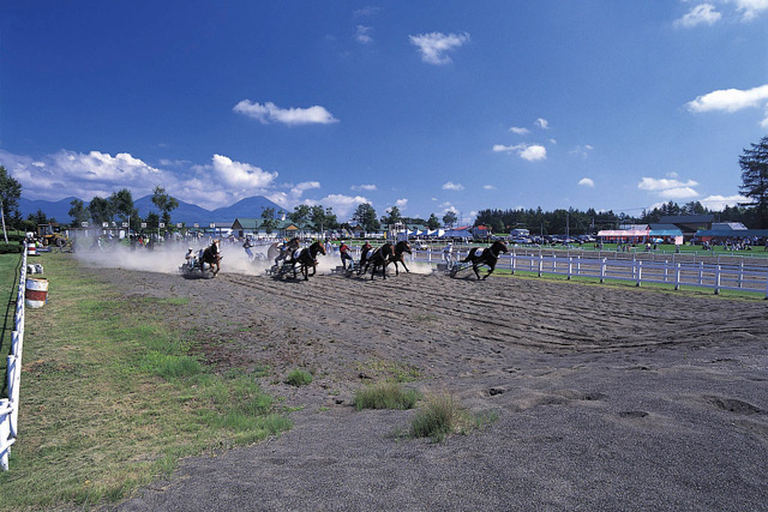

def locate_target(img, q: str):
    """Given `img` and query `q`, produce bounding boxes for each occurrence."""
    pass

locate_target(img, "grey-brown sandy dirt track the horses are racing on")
[91,269,768,511]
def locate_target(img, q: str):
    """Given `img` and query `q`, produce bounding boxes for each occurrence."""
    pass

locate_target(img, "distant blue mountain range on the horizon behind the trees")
[19,195,284,225]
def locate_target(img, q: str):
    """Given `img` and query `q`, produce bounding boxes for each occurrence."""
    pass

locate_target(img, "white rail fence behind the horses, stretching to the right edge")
[410,250,768,298]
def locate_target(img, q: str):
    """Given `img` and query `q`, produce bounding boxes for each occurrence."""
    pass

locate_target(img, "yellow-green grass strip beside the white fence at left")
[0,254,290,511]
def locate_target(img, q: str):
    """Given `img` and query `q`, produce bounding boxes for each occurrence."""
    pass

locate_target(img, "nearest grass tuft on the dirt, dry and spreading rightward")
[410,393,498,443]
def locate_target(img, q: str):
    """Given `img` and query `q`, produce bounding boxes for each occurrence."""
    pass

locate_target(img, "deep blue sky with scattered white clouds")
[0,0,768,220]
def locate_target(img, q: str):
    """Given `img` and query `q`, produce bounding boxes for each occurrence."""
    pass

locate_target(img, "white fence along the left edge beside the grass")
[0,244,27,471]
